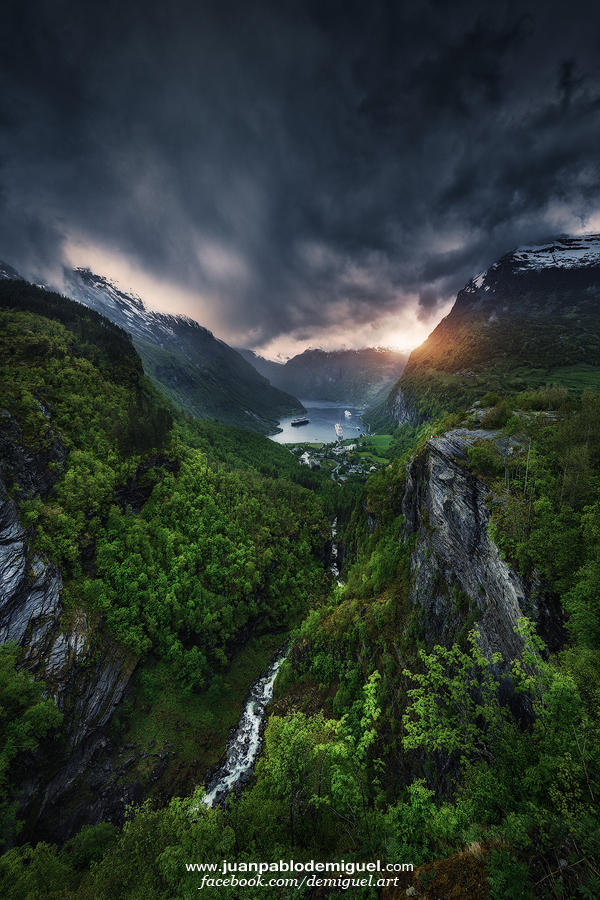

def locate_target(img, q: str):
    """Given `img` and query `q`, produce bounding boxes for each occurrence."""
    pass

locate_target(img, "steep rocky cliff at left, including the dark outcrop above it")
[0,411,136,837]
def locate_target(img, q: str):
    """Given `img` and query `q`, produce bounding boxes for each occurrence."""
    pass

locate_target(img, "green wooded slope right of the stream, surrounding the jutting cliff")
[0,390,600,898]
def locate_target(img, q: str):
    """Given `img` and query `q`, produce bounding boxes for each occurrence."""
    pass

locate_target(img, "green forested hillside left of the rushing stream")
[0,282,333,856]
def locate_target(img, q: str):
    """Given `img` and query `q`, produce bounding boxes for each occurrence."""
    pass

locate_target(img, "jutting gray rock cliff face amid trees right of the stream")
[402,429,539,661]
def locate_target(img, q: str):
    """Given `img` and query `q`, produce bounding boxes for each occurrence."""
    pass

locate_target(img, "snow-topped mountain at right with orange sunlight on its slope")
[376,234,600,425]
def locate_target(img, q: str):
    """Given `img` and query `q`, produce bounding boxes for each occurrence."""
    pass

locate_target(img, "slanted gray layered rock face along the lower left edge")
[0,479,140,840]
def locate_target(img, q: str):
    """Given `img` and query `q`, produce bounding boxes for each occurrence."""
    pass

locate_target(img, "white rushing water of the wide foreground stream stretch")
[203,648,288,806]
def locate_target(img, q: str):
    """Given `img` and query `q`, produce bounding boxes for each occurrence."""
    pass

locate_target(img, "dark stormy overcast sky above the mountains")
[0,0,600,355]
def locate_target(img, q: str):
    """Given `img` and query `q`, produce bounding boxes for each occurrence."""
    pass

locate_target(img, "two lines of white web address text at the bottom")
[185,859,414,890]
